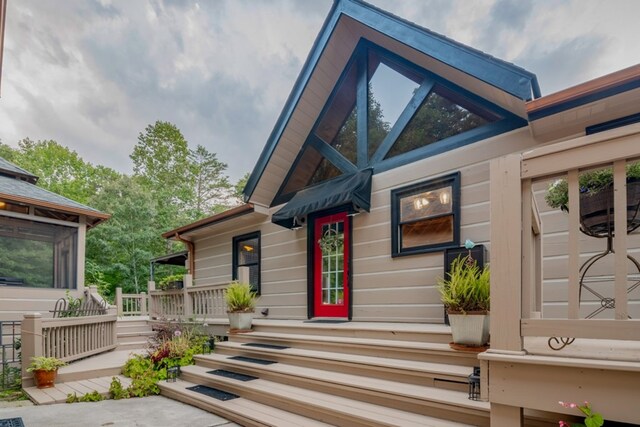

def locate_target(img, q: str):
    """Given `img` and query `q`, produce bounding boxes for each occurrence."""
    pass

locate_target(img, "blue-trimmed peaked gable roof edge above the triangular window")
[244,0,540,204]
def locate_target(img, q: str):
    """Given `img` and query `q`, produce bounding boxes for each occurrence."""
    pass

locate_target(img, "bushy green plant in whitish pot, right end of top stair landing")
[438,256,490,347]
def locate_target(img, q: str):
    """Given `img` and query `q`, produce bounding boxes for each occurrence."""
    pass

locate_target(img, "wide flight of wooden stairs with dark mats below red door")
[161,320,489,426]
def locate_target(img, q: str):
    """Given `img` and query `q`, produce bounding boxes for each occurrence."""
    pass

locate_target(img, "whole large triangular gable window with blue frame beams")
[273,40,526,205]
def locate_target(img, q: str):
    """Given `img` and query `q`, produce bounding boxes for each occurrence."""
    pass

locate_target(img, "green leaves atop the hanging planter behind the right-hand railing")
[544,162,640,211]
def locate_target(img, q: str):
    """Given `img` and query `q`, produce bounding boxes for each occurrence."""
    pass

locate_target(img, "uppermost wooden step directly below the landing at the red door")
[229,332,479,366]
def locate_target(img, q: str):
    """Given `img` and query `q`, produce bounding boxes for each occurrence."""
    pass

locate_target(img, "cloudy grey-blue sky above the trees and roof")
[0,0,640,180]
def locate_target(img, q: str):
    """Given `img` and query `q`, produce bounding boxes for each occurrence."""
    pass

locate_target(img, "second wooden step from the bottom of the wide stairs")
[175,366,476,427]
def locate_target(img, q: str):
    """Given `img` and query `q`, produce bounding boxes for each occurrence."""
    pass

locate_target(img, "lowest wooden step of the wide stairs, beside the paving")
[160,380,330,427]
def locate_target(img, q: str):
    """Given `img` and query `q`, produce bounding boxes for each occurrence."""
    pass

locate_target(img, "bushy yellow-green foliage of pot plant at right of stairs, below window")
[438,256,490,313]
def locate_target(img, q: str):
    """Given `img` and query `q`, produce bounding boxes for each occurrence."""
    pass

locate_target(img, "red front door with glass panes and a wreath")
[313,212,351,317]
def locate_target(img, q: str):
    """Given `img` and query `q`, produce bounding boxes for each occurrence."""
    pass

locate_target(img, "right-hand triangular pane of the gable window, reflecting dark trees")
[385,85,502,159]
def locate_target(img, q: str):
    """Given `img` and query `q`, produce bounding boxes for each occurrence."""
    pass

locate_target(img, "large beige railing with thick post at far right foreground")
[491,125,640,351]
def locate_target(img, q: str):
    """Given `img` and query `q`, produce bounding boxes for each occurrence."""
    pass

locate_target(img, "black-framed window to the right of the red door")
[391,173,460,257]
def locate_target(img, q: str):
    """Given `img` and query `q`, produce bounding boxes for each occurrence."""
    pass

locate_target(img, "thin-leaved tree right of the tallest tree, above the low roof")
[189,145,233,220]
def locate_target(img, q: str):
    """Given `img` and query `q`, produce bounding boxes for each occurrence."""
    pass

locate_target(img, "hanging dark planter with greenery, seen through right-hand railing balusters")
[545,162,640,237]
